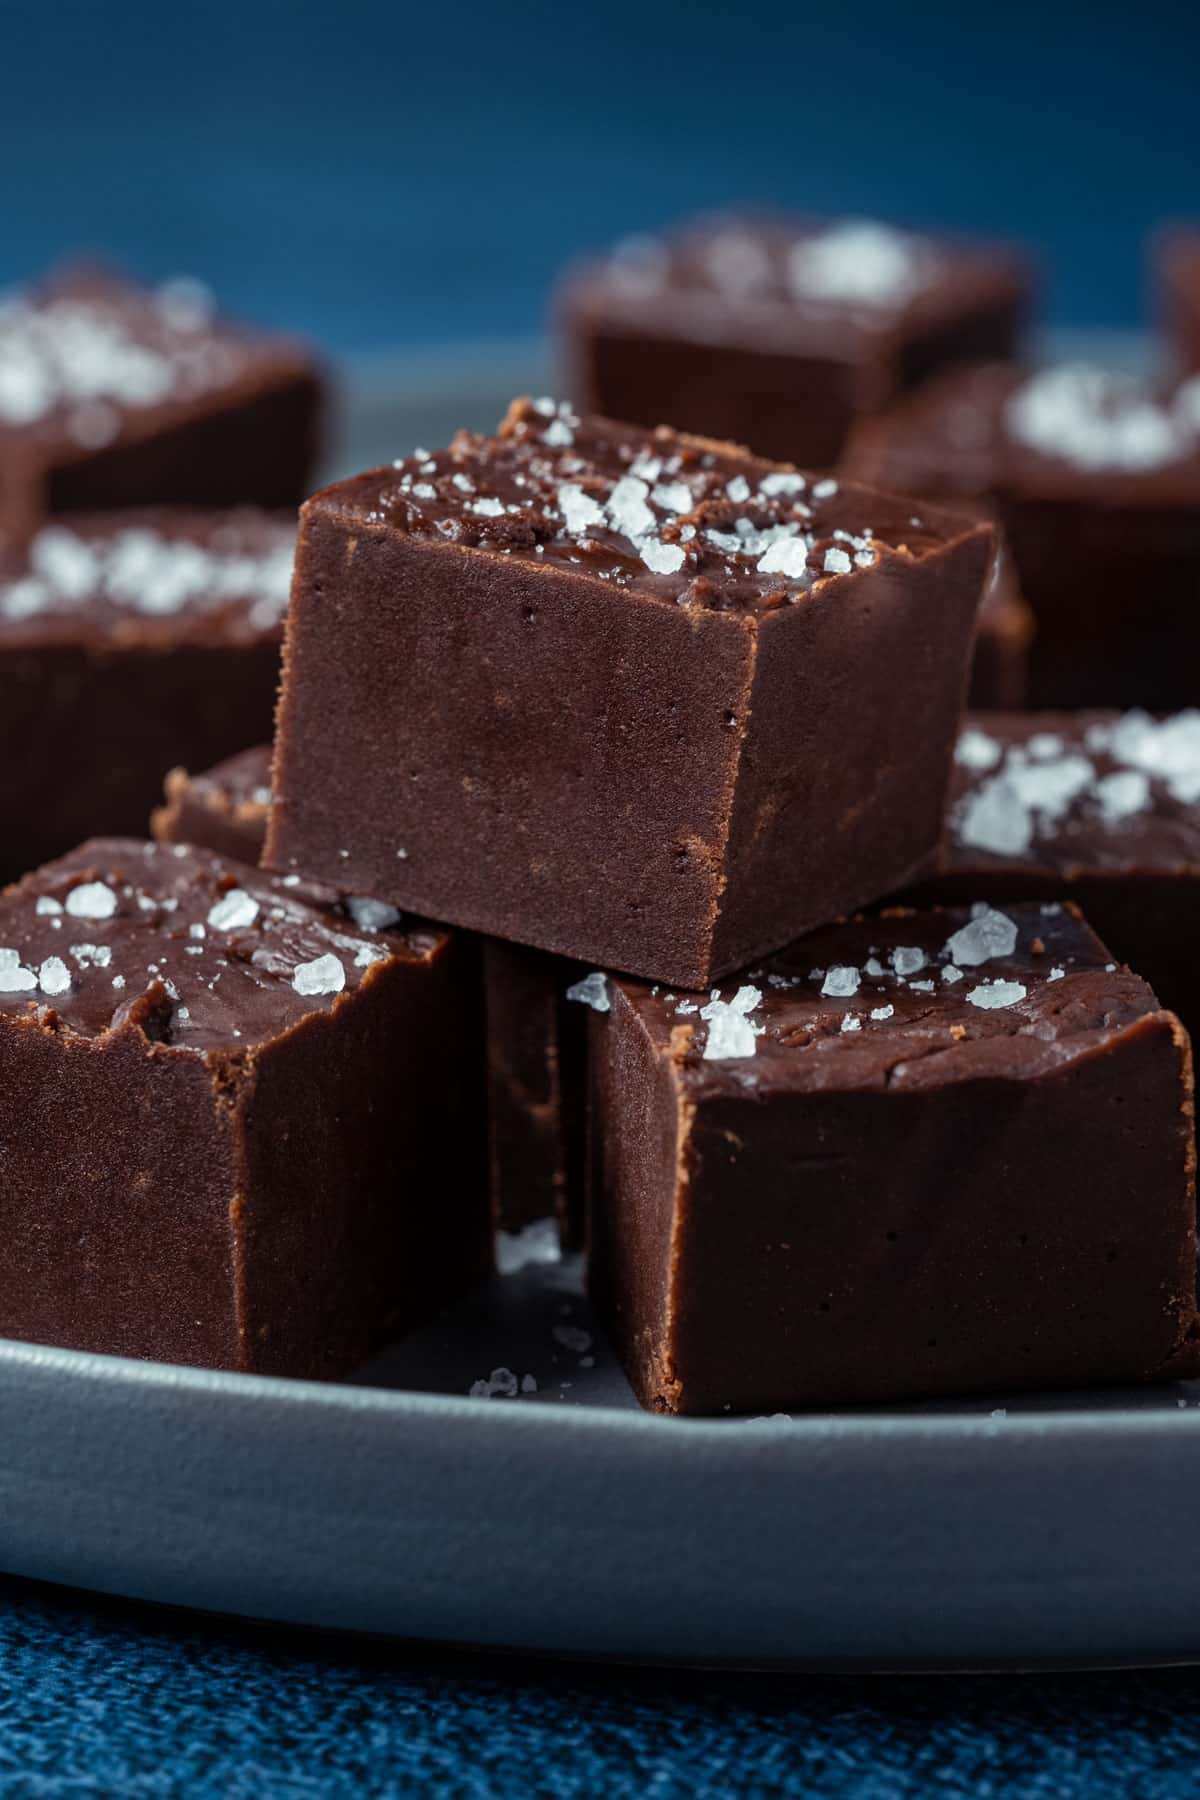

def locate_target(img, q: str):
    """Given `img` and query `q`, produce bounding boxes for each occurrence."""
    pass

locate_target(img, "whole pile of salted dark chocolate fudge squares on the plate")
[0,218,1200,1415]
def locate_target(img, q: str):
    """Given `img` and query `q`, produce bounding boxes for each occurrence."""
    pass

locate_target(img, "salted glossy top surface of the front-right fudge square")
[604,902,1157,1093]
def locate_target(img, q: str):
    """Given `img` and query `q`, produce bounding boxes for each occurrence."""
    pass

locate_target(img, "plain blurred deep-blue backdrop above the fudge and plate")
[0,0,1200,351]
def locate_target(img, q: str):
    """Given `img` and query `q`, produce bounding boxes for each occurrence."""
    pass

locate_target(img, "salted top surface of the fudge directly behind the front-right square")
[943,709,1200,875]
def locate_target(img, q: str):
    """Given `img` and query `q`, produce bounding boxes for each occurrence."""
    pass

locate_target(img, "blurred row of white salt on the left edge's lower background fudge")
[0,520,295,630]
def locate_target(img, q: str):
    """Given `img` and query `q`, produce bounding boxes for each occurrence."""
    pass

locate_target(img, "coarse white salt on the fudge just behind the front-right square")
[950,707,1200,857]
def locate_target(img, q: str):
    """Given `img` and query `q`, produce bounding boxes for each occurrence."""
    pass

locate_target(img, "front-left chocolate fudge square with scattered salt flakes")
[0,839,491,1377]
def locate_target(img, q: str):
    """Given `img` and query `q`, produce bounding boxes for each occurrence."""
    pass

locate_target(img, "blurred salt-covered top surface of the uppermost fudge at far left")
[0,268,309,452]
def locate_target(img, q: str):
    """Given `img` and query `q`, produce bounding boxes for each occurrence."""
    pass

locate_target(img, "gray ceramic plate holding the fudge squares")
[0,346,1200,1667]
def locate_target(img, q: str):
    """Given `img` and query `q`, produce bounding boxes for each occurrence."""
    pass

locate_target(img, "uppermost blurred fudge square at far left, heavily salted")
[0,268,322,533]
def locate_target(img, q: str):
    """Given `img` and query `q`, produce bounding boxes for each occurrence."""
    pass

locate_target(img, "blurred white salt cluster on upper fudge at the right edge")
[1006,362,1200,473]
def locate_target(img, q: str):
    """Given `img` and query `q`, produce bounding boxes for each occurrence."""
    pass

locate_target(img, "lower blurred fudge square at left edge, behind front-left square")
[0,508,295,877]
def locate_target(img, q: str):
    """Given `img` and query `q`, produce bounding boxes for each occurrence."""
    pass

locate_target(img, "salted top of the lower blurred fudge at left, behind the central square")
[0,508,295,646]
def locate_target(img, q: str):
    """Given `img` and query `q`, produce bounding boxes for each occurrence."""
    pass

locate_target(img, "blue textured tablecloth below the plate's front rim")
[0,1576,1200,1800]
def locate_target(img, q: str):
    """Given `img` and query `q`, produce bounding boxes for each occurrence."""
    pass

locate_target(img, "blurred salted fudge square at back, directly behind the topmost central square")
[558,216,1031,468]
